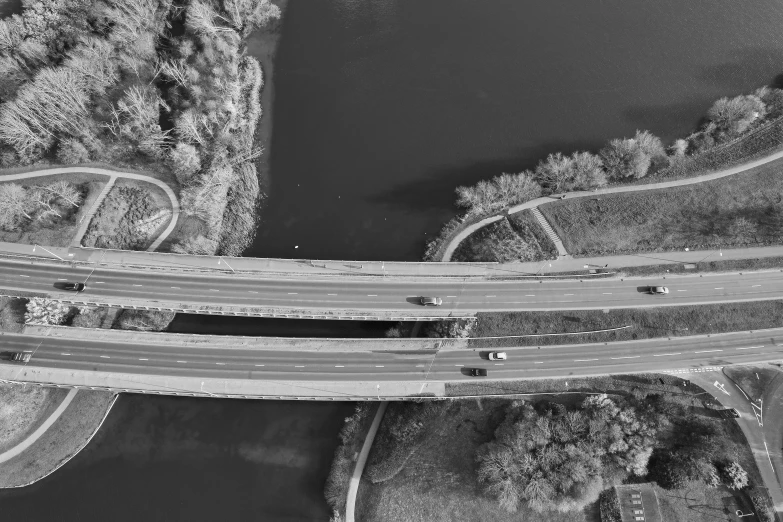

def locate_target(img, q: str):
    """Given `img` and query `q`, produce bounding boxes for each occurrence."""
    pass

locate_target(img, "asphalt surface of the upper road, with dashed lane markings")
[0,260,783,316]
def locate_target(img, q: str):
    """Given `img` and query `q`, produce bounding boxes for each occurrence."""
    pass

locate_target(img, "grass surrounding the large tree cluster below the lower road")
[357,374,759,522]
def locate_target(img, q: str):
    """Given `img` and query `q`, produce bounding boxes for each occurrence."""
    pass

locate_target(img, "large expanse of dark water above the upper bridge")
[245,0,783,260]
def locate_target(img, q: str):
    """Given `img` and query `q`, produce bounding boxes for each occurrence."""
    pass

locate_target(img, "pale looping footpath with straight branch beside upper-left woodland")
[0,167,180,252]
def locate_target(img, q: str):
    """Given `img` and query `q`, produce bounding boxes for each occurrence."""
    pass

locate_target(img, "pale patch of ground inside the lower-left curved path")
[0,383,67,452]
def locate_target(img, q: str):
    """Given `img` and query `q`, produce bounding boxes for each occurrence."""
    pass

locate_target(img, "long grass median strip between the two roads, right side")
[470,301,783,348]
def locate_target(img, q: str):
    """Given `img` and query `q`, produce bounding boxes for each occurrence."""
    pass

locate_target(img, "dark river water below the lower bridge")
[0,395,353,522]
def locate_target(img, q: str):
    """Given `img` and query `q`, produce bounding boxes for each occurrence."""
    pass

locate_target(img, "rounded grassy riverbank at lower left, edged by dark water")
[0,384,117,488]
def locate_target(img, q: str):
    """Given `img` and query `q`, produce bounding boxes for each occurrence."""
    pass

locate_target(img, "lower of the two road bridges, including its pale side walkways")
[0,327,783,400]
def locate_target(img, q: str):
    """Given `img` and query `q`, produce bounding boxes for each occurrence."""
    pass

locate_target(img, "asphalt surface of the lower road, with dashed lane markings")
[0,329,783,382]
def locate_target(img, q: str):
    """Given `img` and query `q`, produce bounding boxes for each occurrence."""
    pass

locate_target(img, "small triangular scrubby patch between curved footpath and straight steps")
[452,210,557,263]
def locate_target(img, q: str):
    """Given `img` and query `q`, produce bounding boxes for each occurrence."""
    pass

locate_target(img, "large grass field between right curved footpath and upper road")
[540,158,783,256]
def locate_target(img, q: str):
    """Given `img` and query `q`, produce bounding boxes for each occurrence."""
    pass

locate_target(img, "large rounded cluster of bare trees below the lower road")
[476,395,658,512]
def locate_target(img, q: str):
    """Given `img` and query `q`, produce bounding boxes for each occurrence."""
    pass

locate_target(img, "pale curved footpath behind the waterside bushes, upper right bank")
[442,150,783,261]
